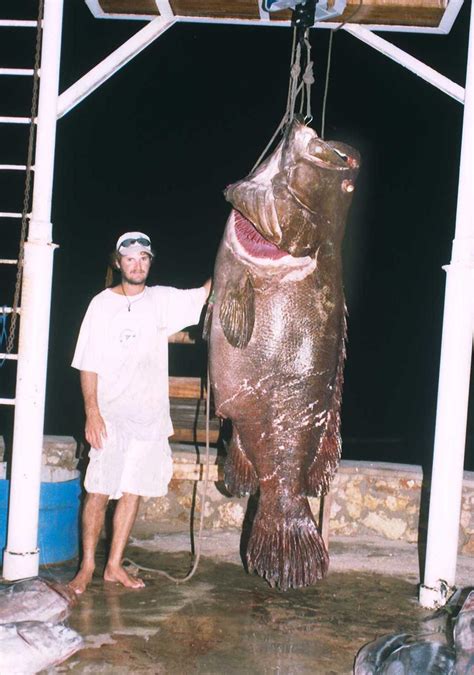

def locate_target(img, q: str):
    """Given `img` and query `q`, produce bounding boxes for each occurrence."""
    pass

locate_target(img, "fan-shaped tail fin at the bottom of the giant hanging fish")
[247,493,329,591]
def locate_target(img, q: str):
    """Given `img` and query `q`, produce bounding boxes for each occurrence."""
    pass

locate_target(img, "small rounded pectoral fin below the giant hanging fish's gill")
[219,275,255,349]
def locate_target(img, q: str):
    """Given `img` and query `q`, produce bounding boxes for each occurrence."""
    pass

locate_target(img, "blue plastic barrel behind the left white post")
[0,478,81,565]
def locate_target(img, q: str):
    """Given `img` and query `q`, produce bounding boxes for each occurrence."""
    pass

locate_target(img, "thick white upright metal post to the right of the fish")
[420,1,474,607]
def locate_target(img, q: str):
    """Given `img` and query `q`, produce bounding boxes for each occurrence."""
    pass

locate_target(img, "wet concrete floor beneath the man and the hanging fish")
[41,531,474,675]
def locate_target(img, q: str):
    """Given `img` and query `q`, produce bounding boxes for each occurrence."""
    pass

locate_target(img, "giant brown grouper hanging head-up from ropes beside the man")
[210,119,359,589]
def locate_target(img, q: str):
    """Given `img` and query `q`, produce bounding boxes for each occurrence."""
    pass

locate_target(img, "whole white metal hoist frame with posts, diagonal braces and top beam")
[0,0,474,607]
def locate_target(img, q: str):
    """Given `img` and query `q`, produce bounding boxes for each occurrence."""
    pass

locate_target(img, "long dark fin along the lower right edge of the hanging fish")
[306,314,346,497]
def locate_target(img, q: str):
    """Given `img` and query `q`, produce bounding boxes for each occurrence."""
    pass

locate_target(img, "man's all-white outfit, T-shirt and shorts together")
[72,286,206,499]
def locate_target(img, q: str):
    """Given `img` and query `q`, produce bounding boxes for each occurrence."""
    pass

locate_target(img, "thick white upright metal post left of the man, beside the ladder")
[3,0,63,580]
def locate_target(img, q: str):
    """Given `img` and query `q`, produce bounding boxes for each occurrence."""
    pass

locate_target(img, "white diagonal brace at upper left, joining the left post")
[58,16,176,119]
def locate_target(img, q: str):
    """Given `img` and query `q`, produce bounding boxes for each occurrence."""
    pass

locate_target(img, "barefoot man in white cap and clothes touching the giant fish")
[69,232,211,593]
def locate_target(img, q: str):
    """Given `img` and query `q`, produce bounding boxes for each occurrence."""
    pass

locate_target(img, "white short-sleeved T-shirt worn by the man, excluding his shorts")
[72,286,206,440]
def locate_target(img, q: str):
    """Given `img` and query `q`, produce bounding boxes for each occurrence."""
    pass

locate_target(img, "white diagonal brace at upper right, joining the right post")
[342,24,464,103]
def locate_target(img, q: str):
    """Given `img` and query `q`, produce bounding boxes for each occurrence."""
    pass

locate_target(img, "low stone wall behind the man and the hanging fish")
[0,436,474,555]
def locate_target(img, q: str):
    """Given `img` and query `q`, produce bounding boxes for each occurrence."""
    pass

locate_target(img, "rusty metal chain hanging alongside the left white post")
[6,0,44,354]
